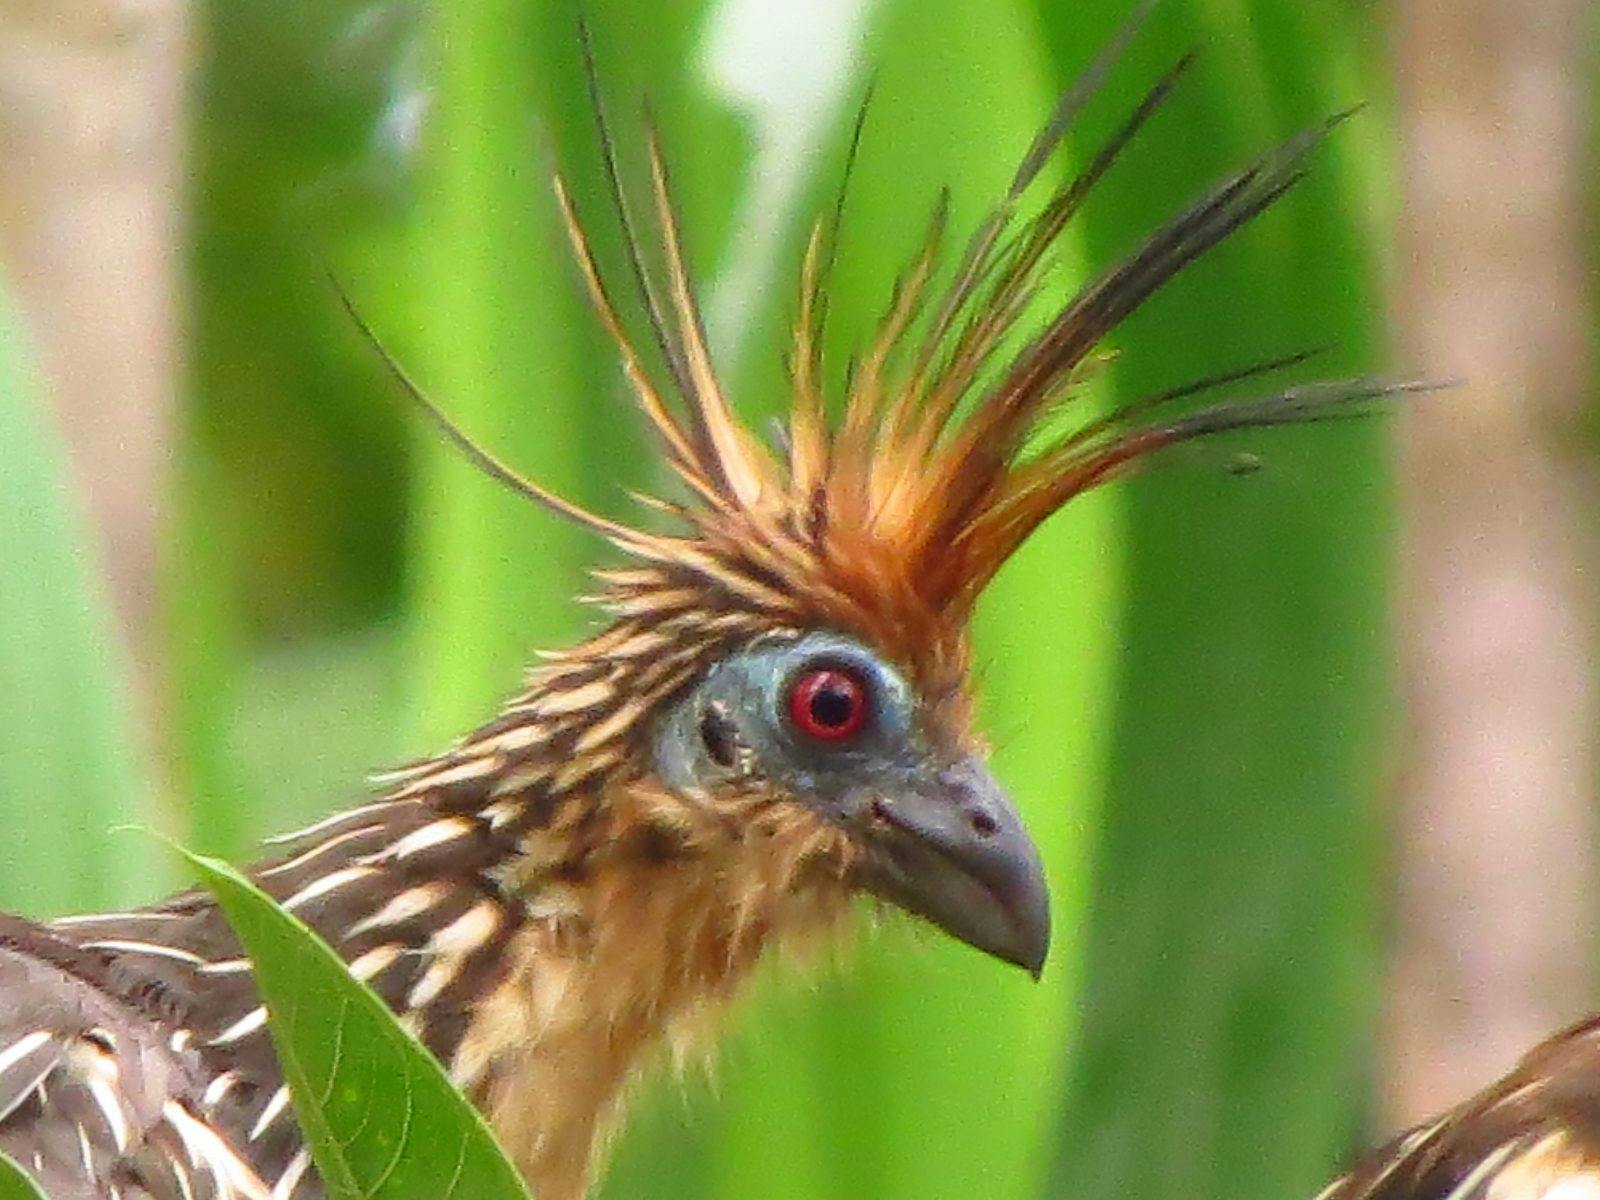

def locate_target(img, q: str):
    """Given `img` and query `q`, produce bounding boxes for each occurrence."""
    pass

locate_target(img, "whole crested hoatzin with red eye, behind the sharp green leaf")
[0,14,1440,1200]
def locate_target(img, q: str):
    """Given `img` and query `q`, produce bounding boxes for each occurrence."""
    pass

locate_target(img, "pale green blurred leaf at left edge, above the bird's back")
[0,270,146,915]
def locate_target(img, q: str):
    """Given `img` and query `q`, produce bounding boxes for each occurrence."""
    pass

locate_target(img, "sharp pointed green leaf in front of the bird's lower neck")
[181,851,528,1200]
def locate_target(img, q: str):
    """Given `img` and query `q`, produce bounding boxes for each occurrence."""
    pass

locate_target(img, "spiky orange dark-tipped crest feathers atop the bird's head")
[531,13,1394,684]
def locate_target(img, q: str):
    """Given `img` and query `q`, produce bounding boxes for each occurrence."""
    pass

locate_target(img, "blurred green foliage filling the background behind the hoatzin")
[0,0,1392,1200]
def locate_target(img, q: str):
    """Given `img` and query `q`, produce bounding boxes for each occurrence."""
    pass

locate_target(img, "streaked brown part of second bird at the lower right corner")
[1317,1018,1600,1200]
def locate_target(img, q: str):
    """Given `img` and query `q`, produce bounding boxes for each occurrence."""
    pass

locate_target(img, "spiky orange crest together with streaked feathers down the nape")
[363,3,1398,803]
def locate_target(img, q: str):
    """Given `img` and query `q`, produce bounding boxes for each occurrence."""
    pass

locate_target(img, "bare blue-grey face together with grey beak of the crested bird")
[653,630,1050,976]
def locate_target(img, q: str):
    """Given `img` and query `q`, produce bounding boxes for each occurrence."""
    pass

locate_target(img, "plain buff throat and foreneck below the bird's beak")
[454,784,846,1200]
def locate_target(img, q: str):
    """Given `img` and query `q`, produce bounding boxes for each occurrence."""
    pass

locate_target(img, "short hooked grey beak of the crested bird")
[856,758,1050,979]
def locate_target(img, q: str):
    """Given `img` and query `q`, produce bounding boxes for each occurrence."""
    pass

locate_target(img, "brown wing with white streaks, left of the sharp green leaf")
[0,917,270,1200]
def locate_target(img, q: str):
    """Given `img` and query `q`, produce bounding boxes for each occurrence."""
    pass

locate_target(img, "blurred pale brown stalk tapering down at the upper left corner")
[0,0,186,701]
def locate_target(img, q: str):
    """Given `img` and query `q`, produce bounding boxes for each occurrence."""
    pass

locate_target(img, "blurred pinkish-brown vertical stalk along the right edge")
[1382,0,1600,1125]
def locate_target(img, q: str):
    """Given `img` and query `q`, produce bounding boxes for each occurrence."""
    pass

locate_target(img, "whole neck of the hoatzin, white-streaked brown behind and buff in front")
[266,774,848,1200]
